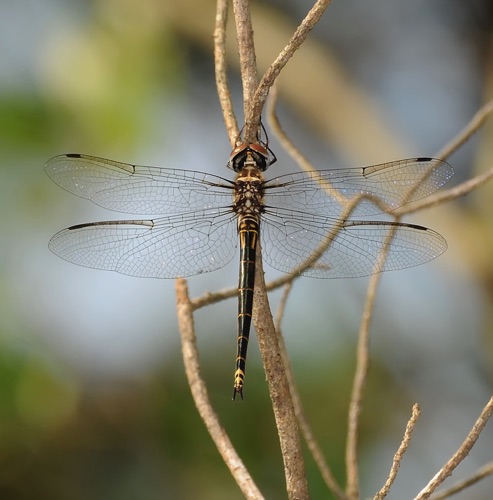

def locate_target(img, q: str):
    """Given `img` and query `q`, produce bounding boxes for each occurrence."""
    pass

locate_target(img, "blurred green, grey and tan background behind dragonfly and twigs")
[0,0,493,500]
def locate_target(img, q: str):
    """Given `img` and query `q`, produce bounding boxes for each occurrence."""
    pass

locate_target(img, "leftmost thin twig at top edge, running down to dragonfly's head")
[214,0,239,147]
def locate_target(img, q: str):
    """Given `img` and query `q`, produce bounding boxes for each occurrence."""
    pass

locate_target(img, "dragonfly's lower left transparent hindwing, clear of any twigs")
[49,209,237,278]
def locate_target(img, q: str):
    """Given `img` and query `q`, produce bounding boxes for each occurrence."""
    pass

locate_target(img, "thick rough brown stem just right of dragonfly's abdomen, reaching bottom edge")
[253,242,308,499]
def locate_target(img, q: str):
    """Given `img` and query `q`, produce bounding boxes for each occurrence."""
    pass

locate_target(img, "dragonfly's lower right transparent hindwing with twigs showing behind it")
[260,209,447,278]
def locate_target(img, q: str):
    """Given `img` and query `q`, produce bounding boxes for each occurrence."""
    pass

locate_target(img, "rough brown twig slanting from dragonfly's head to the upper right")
[250,0,331,129]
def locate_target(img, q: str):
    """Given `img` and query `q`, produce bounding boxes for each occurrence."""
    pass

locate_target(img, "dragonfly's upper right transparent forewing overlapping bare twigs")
[264,158,454,217]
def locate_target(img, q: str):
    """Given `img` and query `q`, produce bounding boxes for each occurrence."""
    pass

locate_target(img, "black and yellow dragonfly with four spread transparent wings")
[45,133,453,400]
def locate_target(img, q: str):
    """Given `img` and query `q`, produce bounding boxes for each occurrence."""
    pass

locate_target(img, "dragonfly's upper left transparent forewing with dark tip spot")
[45,154,234,215]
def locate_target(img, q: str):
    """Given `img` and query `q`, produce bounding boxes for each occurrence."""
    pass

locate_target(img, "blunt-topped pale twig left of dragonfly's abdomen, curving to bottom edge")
[176,278,264,499]
